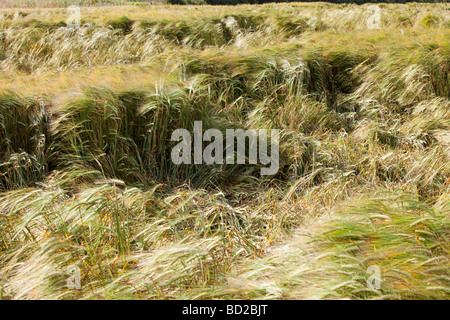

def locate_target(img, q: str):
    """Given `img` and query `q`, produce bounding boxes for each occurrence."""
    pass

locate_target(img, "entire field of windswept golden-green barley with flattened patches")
[0,1,450,300]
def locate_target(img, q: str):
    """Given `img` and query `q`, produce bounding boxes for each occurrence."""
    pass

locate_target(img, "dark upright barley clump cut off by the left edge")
[0,93,52,189]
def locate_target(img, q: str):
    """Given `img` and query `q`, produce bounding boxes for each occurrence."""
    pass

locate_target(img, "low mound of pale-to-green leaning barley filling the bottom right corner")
[222,194,449,300]
